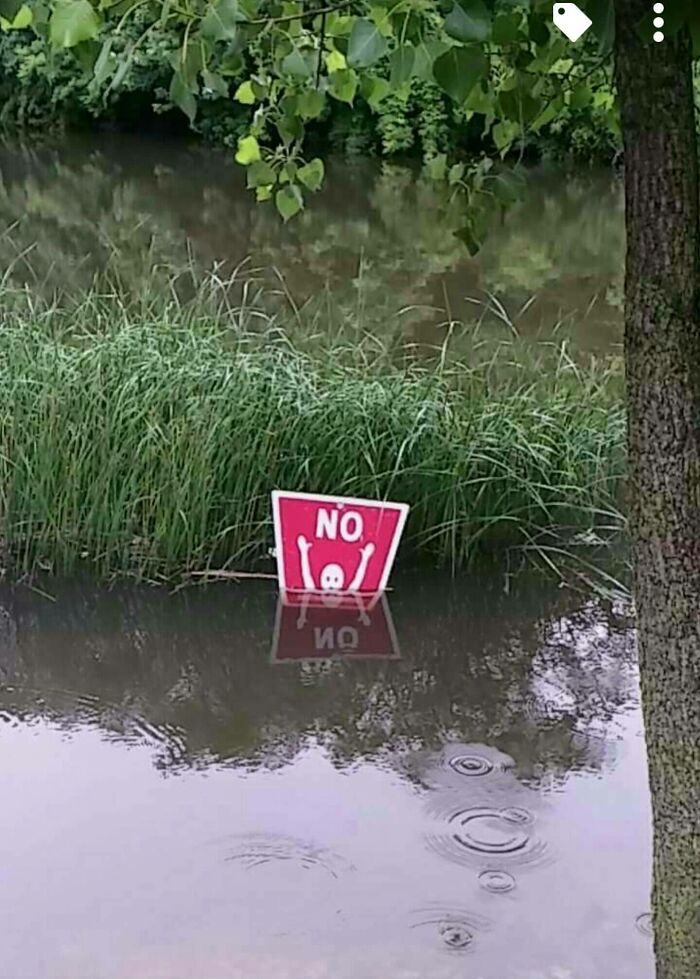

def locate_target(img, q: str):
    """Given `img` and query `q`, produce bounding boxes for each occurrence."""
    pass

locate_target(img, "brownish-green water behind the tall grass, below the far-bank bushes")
[0,135,624,353]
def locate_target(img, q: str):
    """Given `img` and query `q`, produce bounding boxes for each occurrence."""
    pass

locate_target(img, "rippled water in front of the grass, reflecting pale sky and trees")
[0,578,654,979]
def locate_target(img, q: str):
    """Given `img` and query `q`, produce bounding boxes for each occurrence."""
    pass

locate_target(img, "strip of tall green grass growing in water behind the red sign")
[0,278,624,578]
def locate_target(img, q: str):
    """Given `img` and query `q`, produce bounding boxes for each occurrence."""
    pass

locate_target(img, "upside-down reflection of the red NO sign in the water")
[272,592,400,663]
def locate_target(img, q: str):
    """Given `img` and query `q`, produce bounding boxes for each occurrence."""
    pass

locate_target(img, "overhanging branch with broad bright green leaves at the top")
[5,0,700,229]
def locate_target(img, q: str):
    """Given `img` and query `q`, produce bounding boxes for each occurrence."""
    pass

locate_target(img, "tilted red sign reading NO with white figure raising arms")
[272,491,408,593]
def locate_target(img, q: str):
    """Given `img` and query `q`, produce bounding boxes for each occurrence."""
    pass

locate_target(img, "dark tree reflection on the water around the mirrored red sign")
[0,584,633,777]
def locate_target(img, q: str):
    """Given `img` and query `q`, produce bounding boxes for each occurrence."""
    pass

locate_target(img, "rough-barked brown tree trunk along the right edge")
[616,0,700,979]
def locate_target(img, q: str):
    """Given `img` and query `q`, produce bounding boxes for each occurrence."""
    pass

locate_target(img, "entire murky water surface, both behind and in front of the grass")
[0,136,640,979]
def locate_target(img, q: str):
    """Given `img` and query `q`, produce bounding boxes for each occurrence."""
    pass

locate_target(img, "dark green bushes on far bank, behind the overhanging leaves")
[0,0,619,161]
